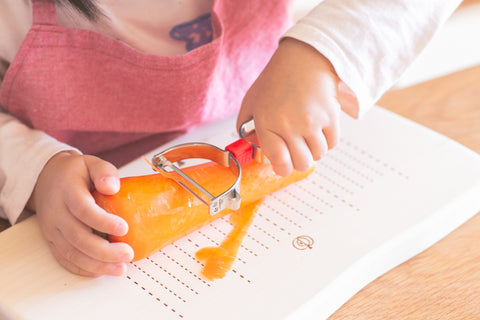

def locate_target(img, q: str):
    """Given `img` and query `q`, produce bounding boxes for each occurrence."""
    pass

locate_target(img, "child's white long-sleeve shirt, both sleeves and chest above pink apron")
[0,0,461,224]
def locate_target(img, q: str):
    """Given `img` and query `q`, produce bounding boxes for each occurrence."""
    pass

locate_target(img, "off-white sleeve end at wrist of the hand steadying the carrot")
[0,107,79,224]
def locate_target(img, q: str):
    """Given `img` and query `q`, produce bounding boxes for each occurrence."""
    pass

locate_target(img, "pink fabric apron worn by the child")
[0,0,290,165]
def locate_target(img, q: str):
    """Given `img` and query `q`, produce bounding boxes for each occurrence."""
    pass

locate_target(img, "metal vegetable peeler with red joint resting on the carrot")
[152,119,264,216]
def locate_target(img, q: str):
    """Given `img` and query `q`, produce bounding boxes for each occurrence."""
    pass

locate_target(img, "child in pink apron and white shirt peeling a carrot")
[0,0,460,276]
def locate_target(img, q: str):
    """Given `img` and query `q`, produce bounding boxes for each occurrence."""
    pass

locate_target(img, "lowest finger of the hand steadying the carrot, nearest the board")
[50,231,126,276]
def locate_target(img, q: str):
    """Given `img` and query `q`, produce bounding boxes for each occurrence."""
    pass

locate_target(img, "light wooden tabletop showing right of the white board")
[329,66,480,320]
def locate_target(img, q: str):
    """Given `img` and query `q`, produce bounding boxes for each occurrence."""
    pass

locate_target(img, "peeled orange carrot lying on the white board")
[93,162,313,261]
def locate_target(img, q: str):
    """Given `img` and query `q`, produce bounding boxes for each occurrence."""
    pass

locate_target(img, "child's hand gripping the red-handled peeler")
[237,38,340,176]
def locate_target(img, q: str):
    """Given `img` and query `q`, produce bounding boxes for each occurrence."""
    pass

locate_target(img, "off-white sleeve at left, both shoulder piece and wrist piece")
[0,0,79,224]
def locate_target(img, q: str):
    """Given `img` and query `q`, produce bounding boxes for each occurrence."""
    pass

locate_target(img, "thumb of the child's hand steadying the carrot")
[85,156,120,195]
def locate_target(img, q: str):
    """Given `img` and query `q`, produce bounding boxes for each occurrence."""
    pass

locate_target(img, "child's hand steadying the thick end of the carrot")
[29,152,133,276]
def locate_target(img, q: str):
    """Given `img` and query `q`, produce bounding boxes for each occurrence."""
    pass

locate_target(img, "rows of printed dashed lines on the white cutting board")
[124,139,408,318]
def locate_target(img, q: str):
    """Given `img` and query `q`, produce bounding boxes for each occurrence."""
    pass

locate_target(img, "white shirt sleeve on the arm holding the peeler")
[284,0,461,118]
